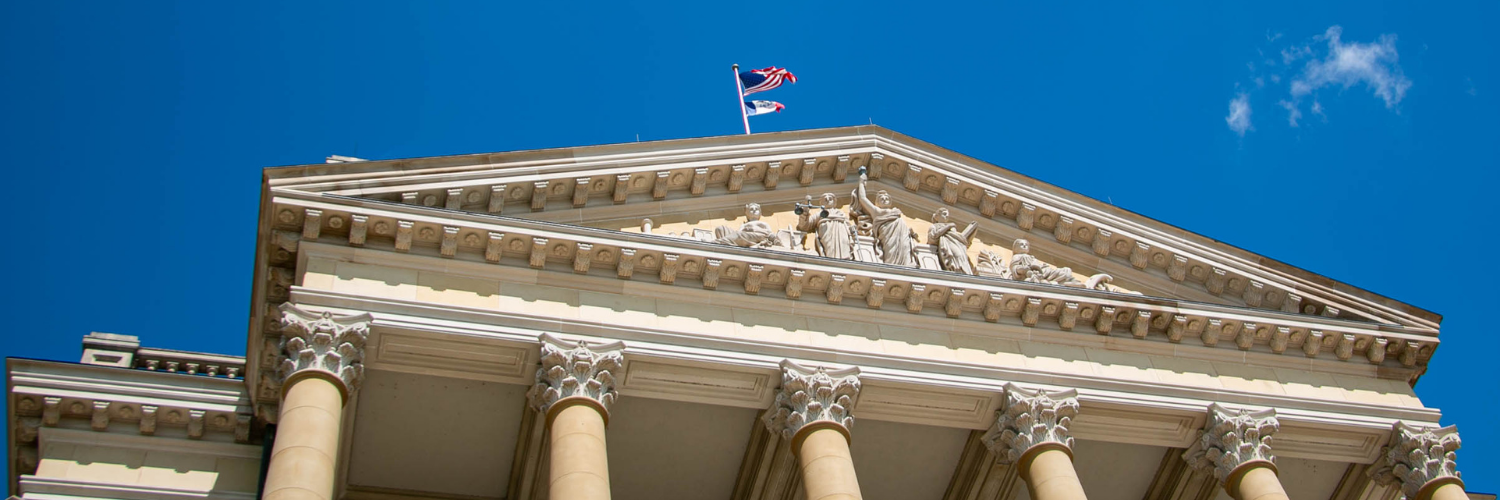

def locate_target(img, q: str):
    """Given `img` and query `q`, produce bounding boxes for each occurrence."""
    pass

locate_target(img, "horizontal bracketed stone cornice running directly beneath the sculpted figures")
[273,194,1439,375]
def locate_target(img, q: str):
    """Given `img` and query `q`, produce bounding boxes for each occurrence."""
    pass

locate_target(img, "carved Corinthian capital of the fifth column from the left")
[1182,402,1281,482]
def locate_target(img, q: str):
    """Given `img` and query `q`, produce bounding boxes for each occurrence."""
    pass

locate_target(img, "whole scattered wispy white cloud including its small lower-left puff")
[1224,26,1410,137]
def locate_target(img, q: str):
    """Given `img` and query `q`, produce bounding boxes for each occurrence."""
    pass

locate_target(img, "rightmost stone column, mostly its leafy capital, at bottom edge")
[1370,422,1469,500]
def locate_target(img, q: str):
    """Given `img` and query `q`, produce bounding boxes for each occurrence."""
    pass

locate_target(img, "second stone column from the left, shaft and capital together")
[527,333,626,500]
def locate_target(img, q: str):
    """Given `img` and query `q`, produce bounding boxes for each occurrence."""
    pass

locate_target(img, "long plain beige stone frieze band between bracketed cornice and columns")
[295,261,1422,408]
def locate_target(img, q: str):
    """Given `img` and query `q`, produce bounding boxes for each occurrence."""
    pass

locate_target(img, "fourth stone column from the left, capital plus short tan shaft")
[984,384,1086,500]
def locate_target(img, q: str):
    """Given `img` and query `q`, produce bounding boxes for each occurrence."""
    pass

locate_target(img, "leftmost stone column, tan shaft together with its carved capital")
[261,303,371,500]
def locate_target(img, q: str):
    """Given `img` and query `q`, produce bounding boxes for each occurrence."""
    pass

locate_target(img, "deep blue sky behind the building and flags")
[0,2,1500,492]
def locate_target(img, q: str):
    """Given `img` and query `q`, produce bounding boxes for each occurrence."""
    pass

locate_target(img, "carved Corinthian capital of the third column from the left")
[762,359,860,449]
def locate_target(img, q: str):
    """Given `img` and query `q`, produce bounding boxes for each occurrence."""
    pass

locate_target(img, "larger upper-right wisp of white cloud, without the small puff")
[1283,26,1412,108]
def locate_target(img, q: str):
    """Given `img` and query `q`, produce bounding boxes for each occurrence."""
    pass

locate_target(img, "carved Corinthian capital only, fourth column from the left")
[983,384,1079,464]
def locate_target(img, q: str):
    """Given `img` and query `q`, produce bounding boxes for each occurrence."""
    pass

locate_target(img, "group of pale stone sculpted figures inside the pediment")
[704,173,1125,291]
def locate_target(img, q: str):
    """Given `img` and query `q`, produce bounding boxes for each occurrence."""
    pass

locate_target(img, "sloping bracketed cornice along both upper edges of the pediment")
[267,126,1440,332]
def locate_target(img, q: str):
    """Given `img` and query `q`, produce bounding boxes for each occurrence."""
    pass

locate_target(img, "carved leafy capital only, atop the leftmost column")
[276,302,372,399]
